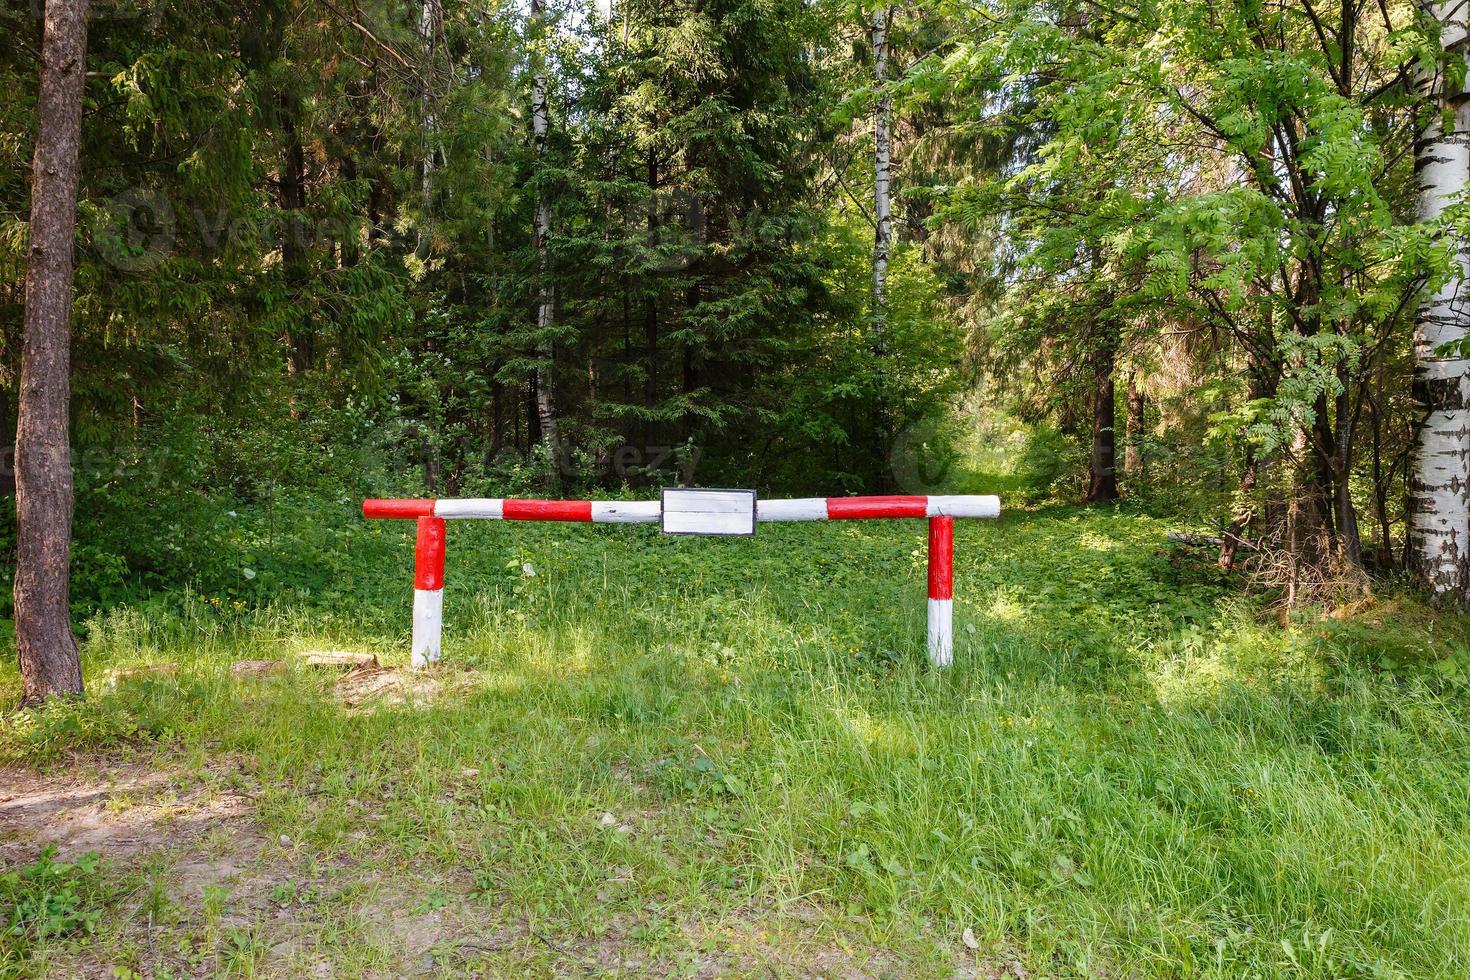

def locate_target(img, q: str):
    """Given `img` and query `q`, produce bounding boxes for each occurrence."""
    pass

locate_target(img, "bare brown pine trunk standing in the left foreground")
[15,0,87,705]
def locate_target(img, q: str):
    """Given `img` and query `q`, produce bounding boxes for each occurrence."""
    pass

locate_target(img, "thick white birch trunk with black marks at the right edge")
[1405,3,1470,601]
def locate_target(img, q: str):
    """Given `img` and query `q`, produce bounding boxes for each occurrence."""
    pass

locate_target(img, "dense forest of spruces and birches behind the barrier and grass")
[0,0,1467,625]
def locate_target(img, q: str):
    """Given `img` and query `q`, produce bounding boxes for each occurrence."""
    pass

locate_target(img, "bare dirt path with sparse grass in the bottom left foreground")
[0,758,940,980]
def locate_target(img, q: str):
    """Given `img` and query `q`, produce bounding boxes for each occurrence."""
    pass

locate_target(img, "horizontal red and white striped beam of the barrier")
[363,495,1001,525]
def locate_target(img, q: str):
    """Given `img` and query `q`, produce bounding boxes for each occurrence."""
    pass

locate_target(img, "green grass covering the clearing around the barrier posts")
[0,508,1470,977]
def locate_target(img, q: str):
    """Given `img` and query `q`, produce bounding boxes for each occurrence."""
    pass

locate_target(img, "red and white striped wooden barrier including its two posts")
[363,491,1001,667]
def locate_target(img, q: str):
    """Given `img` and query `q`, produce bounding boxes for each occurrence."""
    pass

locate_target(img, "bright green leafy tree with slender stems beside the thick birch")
[947,0,1440,598]
